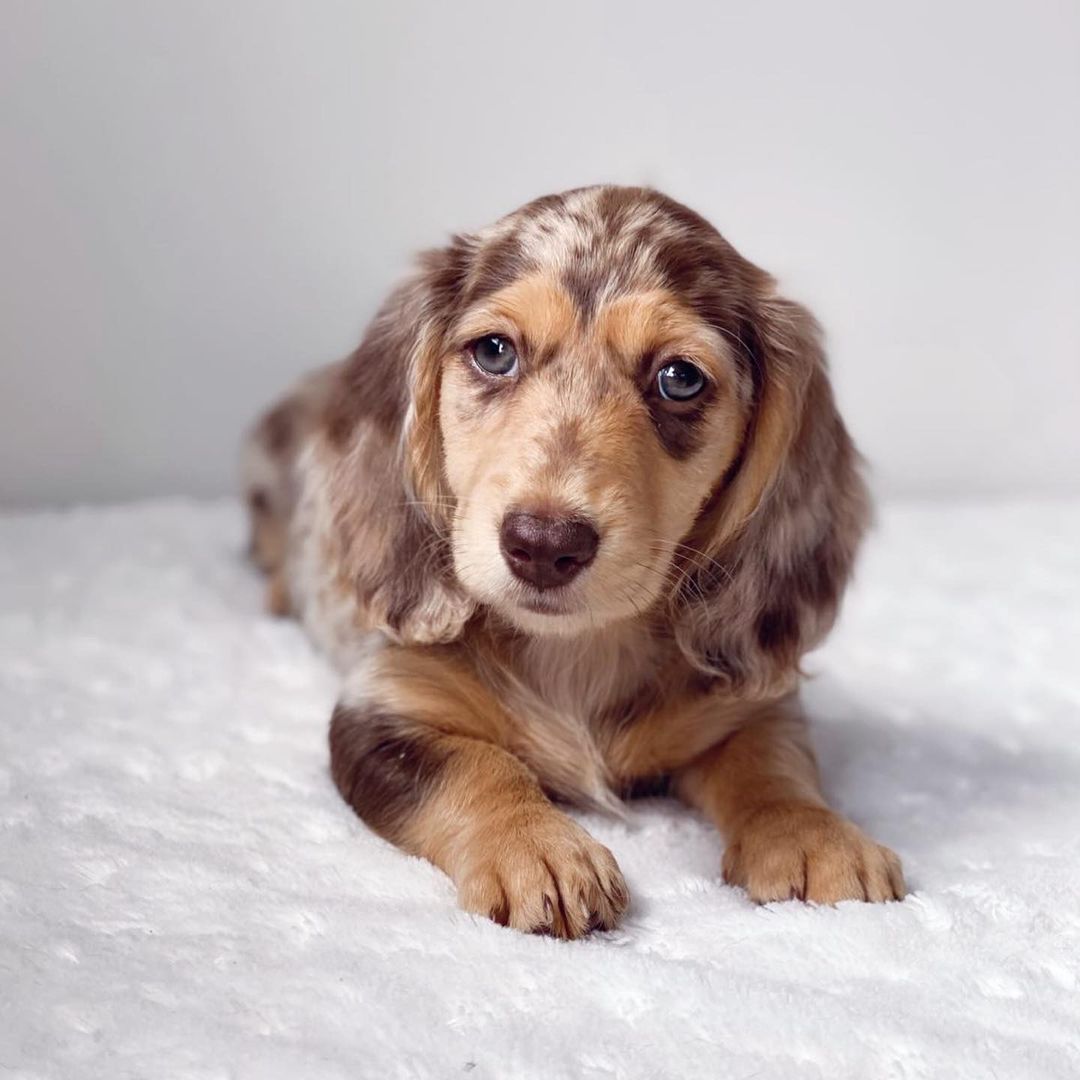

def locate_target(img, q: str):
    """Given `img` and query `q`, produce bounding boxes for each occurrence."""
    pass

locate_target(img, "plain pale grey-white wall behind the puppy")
[0,0,1080,502]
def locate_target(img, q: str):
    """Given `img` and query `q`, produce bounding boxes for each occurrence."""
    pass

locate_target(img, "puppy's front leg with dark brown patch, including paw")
[329,648,629,939]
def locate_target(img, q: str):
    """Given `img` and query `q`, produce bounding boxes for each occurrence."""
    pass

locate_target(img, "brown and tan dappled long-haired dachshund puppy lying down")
[246,187,904,937]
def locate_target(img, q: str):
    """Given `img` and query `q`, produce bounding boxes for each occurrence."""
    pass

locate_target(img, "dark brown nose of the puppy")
[499,510,600,589]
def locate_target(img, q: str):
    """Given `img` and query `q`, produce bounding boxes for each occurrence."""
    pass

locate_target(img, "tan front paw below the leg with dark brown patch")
[457,808,630,939]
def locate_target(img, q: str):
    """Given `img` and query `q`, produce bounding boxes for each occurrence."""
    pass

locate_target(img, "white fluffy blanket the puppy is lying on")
[0,502,1080,1080]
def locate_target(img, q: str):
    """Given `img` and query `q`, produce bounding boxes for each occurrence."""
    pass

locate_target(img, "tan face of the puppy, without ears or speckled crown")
[440,270,751,634]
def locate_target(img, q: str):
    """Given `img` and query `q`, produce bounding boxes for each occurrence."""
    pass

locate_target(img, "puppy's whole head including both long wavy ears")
[327,187,865,687]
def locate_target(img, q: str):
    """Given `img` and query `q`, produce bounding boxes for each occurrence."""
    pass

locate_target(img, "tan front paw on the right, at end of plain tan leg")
[724,805,907,904]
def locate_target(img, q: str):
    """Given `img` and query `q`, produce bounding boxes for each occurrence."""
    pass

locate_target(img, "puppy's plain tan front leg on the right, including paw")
[674,705,906,904]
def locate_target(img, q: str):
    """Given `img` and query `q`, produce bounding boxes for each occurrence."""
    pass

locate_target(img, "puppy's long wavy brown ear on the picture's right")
[674,282,869,696]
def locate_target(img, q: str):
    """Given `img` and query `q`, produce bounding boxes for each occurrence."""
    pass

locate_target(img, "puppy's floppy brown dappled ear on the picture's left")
[319,238,473,644]
